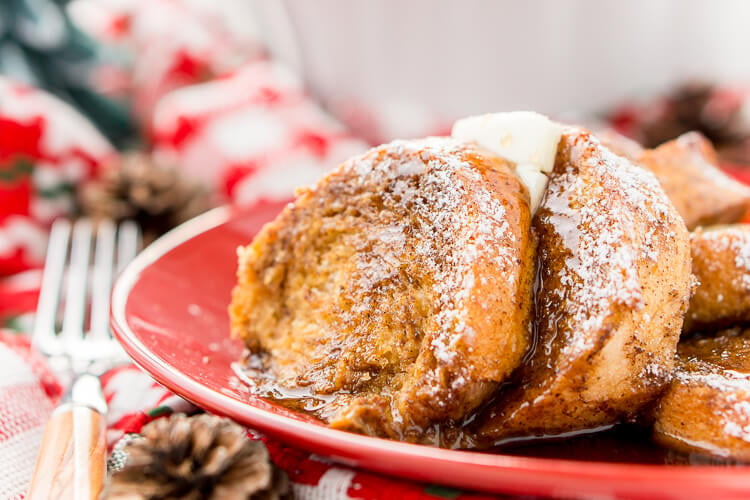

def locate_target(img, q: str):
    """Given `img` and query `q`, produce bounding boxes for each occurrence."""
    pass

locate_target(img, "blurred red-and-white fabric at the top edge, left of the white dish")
[71,0,264,127]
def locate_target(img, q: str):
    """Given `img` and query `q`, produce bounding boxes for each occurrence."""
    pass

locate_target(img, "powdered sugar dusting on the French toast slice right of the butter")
[540,131,674,355]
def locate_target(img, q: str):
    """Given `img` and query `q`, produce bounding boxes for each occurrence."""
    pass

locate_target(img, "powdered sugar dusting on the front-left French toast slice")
[343,138,517,394]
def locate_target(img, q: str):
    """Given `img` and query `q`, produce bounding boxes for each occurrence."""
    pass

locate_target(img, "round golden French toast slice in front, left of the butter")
[230,138,534,444]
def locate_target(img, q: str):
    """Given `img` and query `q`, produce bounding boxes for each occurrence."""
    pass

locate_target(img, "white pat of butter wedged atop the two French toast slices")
[451,111,562,213]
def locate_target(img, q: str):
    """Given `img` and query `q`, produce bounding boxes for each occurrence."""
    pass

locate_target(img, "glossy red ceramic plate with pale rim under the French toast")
[112,203,750,499]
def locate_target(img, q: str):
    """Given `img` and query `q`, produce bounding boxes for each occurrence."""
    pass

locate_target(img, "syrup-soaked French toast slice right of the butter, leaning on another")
[478,129,692,443]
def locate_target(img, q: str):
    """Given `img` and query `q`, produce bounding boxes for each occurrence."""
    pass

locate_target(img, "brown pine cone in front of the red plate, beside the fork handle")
[102,414,292,500]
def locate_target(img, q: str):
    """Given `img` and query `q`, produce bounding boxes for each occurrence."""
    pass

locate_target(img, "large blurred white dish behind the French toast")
[254,0,750,141]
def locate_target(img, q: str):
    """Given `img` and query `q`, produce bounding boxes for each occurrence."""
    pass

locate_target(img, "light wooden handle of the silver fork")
[26,403,107,500]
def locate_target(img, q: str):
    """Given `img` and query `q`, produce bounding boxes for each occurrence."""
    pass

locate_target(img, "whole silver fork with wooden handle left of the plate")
[26,219,140,500]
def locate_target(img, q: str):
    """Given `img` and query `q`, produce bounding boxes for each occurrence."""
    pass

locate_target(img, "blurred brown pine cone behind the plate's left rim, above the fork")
[78,152,211,244]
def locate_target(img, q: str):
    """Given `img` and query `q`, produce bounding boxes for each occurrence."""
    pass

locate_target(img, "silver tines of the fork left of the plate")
[32,219,141,356]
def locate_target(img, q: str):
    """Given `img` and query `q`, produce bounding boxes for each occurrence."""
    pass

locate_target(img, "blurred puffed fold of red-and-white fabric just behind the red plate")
[153,61,367,203]
